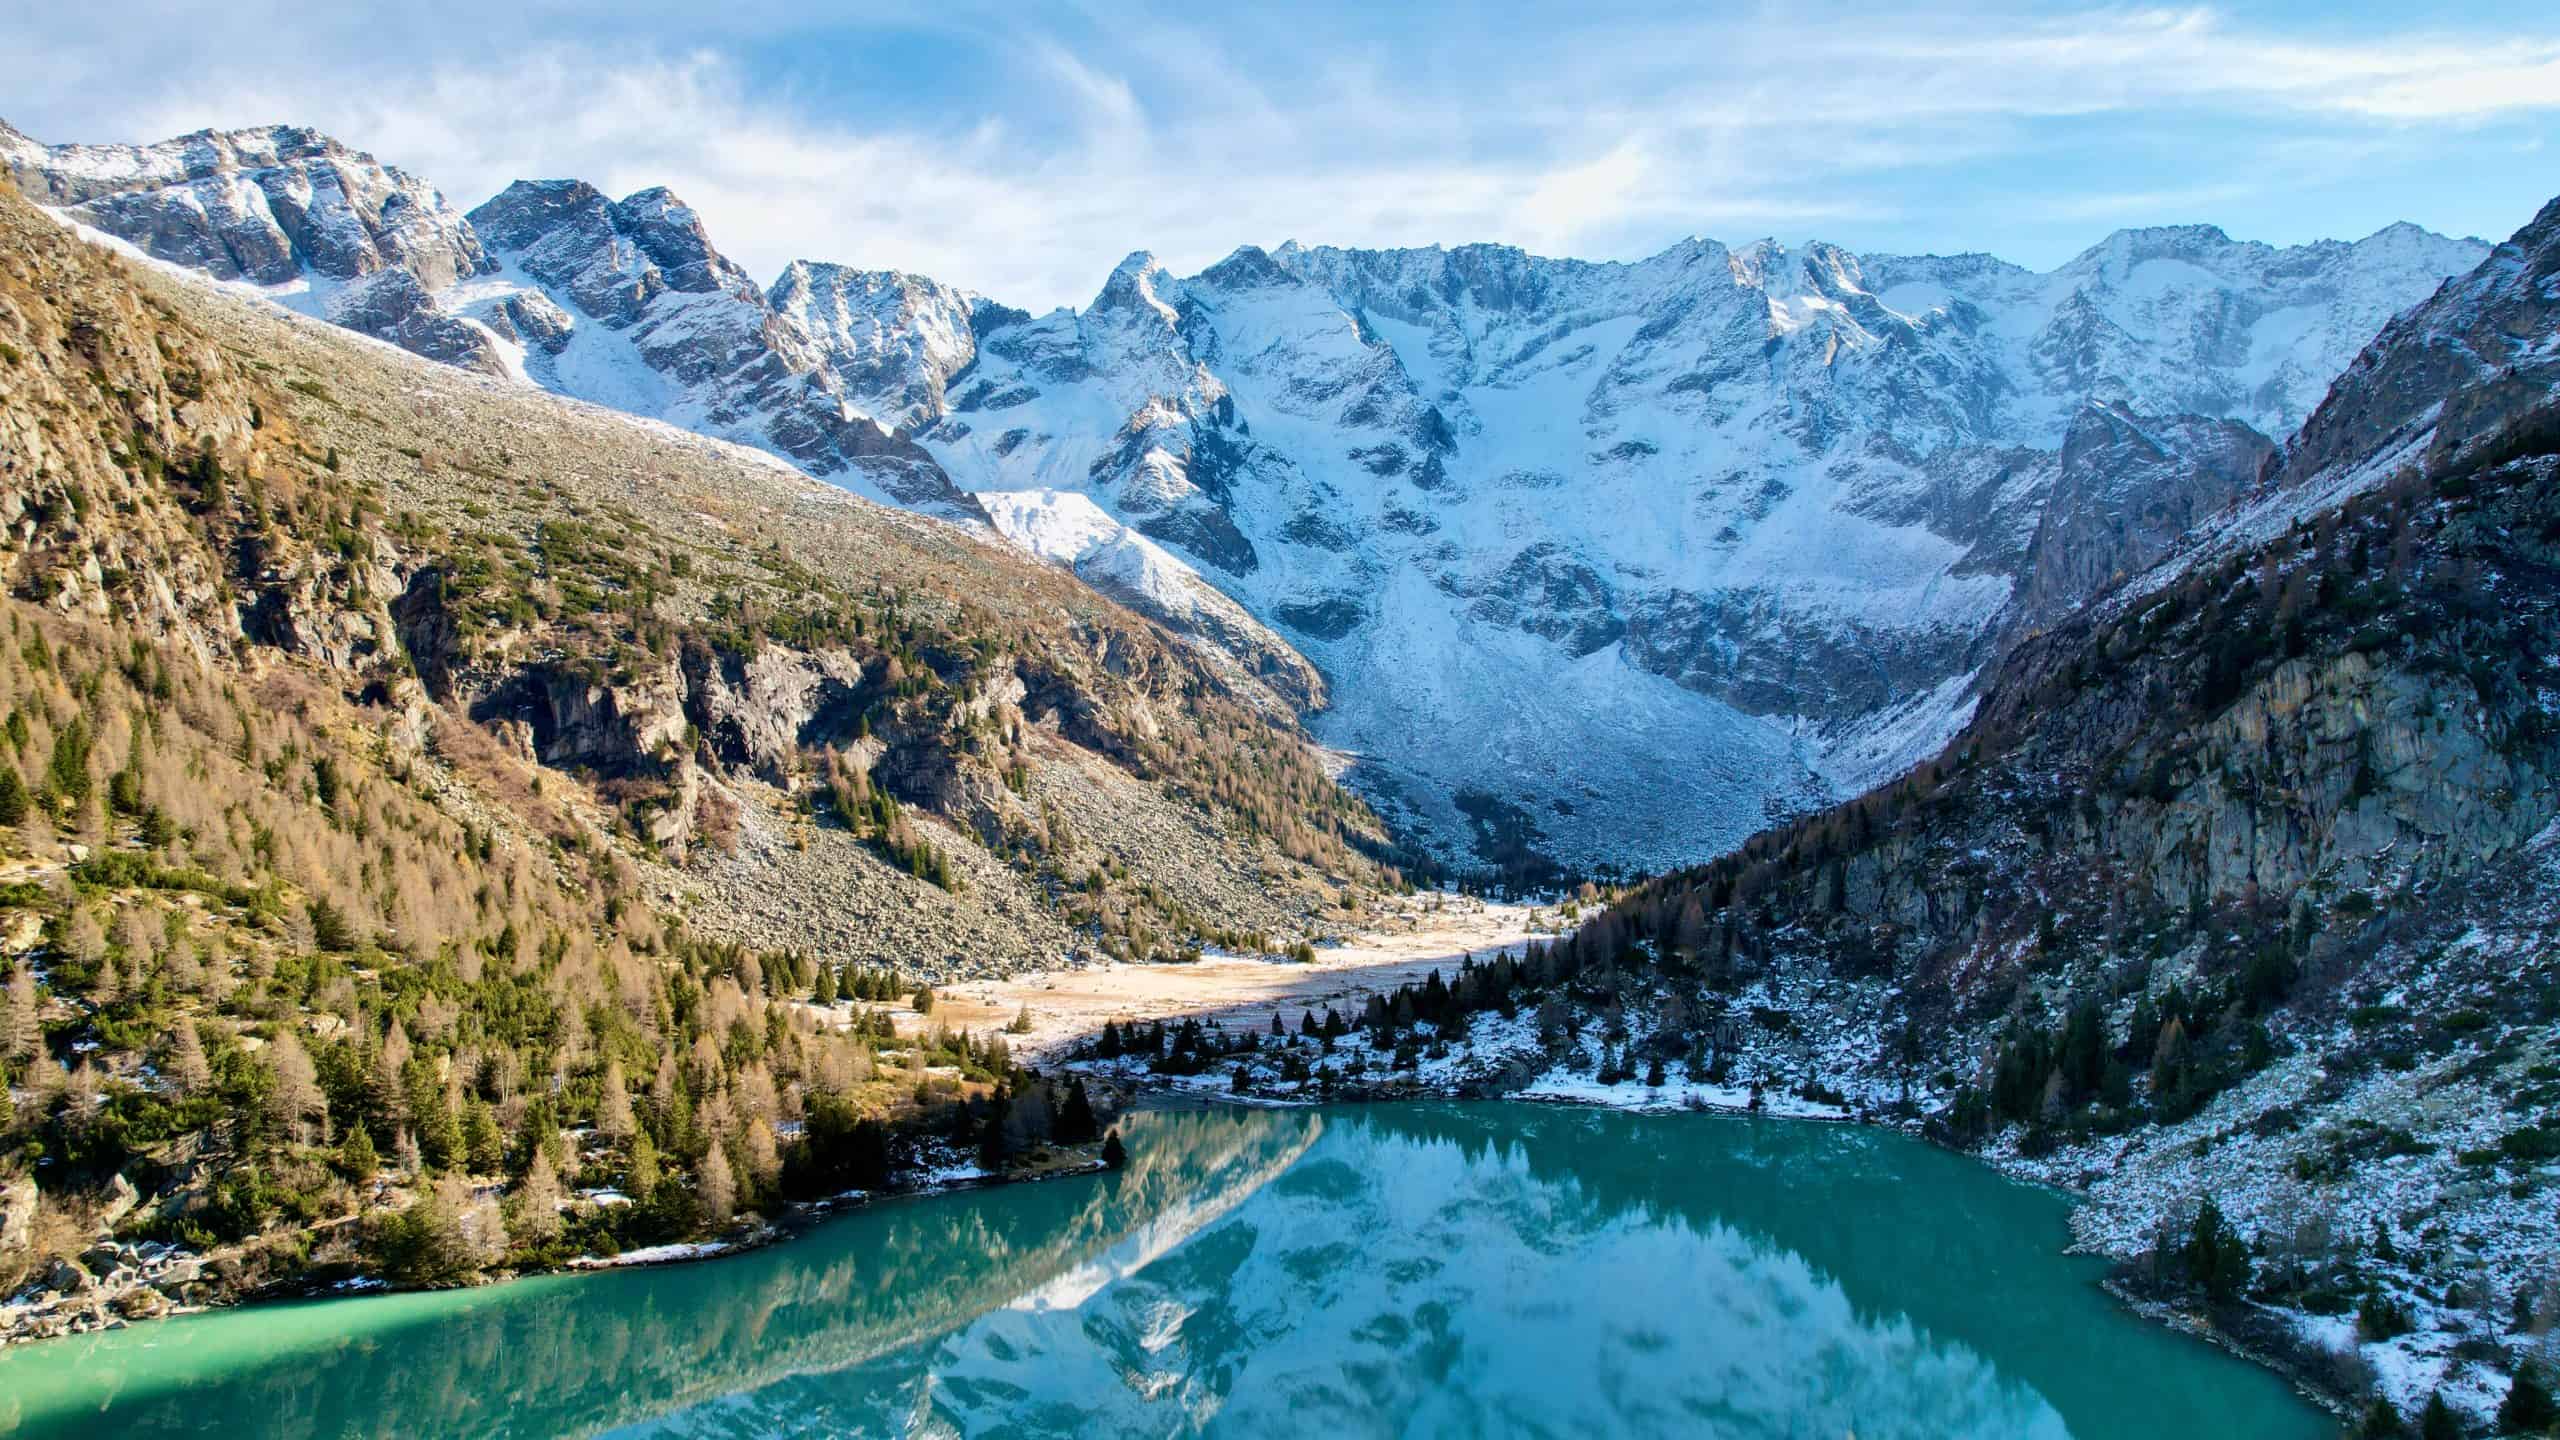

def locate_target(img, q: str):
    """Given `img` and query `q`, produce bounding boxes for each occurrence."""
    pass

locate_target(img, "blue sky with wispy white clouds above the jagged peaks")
[0,0,2560,307]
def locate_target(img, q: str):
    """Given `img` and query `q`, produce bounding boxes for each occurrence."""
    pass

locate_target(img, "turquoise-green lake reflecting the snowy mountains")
[0,1104,2335,1440]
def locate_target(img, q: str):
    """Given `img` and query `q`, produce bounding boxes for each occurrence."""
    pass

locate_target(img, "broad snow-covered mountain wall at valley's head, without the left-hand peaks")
[896,225,2486,863]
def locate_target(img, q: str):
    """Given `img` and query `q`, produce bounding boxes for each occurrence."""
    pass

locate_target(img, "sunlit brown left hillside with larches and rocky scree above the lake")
[0,190,1400,1327]
